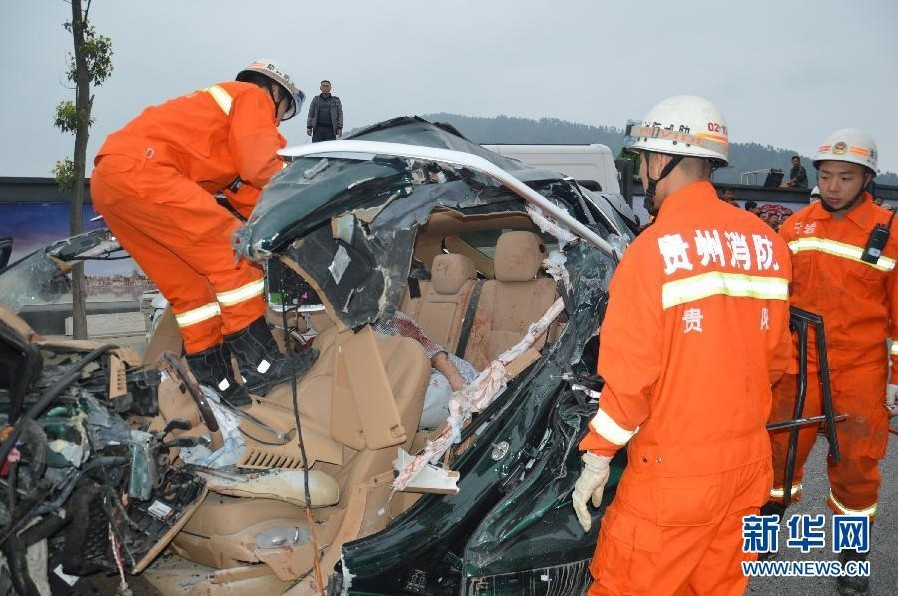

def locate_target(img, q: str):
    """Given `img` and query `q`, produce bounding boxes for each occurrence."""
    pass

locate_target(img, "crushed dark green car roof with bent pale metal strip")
[235,118,617,328]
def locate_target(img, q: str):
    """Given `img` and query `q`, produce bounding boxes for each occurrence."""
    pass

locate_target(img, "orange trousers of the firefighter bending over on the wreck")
[91,155,265,354]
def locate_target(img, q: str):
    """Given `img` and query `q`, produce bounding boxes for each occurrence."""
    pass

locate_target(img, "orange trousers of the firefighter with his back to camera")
[589,458,771,596]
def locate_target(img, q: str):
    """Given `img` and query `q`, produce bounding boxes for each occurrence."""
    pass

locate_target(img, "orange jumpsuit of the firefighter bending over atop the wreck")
[91,82,286,354]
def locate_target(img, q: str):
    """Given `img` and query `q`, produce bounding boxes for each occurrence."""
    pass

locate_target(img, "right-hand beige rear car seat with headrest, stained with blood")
[464,231,558,370]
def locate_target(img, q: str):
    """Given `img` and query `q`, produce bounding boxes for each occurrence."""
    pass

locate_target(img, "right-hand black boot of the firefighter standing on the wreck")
[225,317,295,396]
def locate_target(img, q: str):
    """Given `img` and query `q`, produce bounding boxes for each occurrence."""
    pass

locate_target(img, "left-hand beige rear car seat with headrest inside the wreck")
[400,254,477,352]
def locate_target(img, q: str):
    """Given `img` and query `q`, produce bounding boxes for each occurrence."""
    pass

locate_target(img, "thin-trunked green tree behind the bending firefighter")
[53,0,112,339]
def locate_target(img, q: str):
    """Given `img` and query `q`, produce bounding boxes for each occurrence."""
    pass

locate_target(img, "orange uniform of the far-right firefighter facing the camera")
[771,193,898,517]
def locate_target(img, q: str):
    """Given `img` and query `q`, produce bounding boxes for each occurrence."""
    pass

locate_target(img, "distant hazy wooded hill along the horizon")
[422,113,898,186]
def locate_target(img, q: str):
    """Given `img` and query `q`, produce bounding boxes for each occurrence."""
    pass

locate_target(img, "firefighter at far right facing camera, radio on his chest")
[763,128,898,594]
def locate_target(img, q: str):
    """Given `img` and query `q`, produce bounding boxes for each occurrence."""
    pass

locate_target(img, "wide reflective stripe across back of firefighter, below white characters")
[661,271,789,309]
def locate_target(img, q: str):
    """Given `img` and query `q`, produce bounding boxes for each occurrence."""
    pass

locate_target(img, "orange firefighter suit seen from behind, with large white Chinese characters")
[580,182,791,594]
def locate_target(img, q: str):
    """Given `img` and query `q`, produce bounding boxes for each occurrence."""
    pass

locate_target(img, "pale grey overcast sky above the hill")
[0,0,898,176]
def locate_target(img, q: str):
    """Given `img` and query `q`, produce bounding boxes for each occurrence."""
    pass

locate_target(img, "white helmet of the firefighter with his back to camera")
[625,95,730,167]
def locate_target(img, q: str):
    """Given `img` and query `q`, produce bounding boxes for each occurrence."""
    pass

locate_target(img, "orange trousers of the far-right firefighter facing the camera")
[770,364,888,515]
